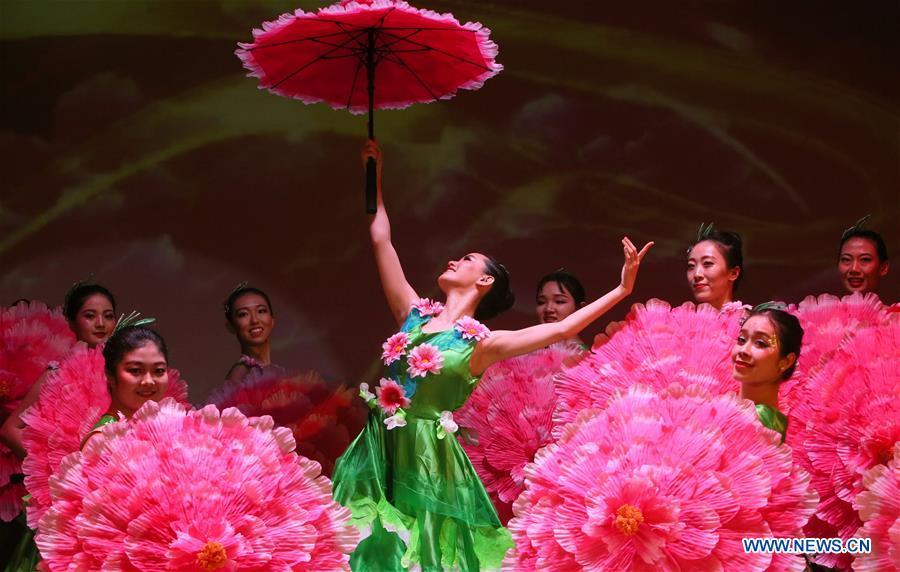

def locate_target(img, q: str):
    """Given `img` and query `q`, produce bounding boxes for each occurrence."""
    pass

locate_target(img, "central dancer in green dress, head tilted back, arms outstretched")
[333,141,652,571]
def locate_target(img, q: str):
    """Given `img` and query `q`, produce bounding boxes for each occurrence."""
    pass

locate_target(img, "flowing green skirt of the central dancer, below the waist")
[333,411,513,572]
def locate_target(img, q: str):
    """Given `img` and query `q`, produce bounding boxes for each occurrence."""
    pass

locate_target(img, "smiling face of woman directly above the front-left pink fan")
[109,342,169,417]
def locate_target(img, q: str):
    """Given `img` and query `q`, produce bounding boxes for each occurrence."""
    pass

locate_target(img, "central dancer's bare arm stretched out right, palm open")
[469,237,653,375]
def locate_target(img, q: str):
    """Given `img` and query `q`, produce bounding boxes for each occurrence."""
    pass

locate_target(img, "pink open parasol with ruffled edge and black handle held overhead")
[235,0,503,213]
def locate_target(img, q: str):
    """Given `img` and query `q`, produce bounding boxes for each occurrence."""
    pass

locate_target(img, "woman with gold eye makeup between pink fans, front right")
[731,302,803,442]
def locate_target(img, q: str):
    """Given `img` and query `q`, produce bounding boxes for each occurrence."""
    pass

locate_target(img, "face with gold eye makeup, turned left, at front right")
[731,316,793,385]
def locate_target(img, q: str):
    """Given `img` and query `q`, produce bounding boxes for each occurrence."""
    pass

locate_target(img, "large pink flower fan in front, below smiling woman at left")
[36,399,359,571]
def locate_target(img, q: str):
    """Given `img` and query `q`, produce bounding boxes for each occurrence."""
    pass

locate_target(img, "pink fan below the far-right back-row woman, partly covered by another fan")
[779,293,890,415]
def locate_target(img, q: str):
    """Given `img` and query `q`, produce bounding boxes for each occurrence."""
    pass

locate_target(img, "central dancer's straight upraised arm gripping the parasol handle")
[362,139,419,324]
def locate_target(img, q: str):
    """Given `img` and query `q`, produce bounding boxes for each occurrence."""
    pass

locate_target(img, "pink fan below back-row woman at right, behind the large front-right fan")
[555,300,743,434]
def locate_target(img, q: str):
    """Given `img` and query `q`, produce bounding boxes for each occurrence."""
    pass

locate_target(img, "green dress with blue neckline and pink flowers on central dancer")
[333,307,513,572]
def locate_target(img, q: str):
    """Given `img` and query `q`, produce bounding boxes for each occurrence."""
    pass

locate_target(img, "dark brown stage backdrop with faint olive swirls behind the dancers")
[0,0,900,402]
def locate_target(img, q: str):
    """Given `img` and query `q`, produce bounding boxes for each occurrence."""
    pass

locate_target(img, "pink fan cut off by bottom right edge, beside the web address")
[853,452,900,572]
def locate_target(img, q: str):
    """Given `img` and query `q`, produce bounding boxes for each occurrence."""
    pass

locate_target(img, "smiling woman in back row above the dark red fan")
[225,282,275,381]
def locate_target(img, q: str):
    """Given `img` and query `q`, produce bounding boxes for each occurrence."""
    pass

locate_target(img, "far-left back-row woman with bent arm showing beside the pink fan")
[0,282,116,458]
